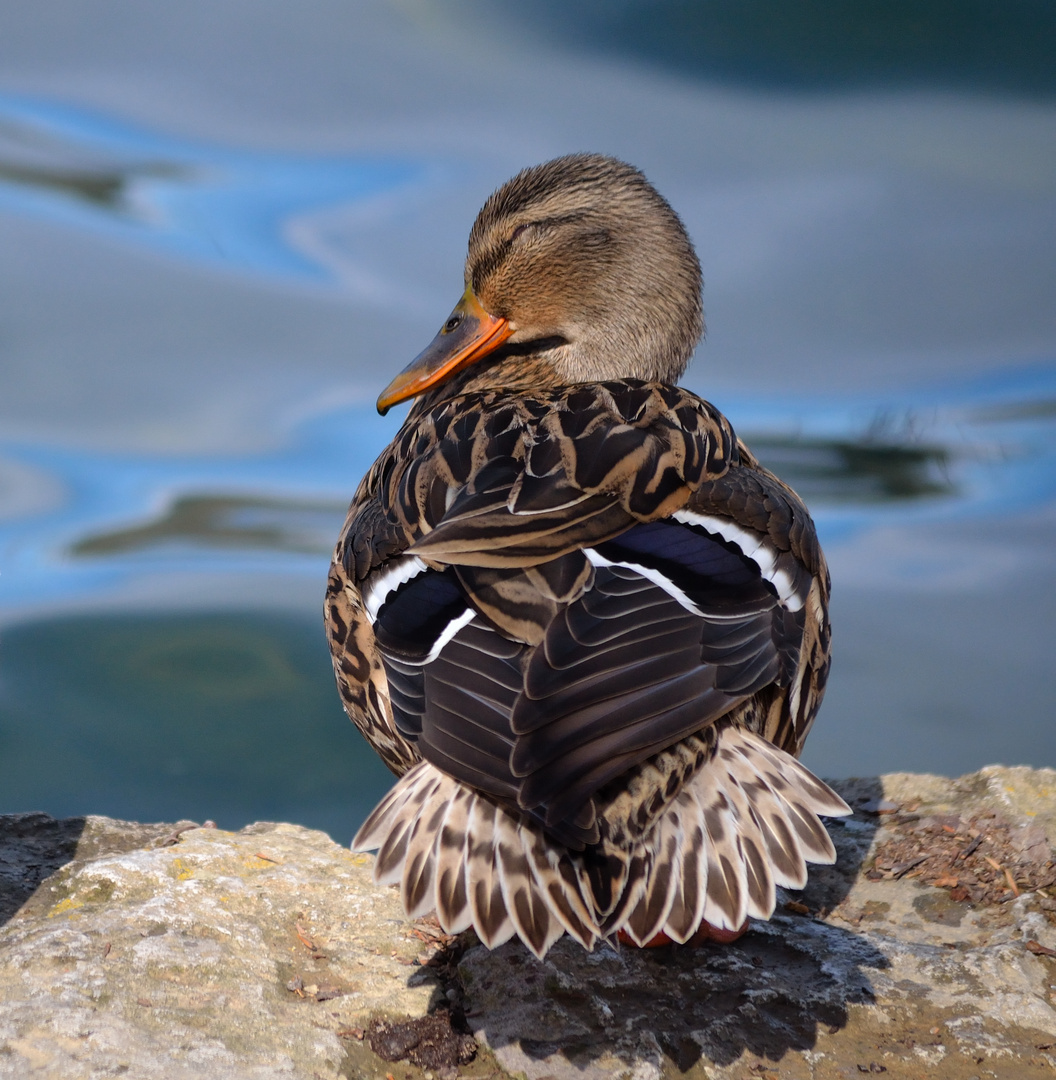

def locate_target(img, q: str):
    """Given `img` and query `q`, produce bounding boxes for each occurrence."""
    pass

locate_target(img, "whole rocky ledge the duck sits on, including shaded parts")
[0,767,1056,1080]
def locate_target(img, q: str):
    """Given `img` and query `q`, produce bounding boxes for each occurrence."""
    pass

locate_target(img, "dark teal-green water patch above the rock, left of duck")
[0,611,391,841]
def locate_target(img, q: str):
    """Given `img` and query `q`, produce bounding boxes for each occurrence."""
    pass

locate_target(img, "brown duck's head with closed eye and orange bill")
[378,153,703,414]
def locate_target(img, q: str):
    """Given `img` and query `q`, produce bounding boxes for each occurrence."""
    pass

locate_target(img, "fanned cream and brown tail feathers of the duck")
[352,727,850,957]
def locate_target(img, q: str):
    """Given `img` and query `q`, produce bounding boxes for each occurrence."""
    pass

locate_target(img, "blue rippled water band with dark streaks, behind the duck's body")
[0,365,1056,618]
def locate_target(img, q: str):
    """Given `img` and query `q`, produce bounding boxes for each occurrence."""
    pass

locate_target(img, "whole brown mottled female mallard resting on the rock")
[327,154,849,956]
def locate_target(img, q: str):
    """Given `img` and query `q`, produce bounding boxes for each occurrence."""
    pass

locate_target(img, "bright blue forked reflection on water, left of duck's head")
[0,95,431,281]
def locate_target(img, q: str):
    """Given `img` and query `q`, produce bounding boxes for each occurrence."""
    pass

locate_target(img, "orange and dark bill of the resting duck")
[378,287,513,416]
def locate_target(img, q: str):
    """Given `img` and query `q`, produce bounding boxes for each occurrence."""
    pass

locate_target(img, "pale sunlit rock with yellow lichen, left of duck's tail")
[0,815,439,1080]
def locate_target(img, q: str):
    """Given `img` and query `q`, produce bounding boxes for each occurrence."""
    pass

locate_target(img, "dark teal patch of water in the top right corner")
[472,0,1056,96]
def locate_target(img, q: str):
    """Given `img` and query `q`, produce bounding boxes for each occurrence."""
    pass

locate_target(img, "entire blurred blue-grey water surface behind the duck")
[0,0,1056,840]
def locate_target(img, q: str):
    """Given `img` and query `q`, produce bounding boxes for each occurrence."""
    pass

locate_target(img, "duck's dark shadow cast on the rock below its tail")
[459,779,888,1080]
